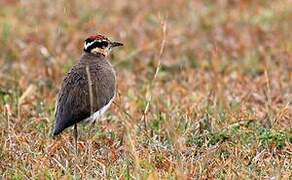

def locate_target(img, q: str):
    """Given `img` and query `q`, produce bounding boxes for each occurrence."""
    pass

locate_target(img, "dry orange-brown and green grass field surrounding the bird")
[0,0,292,179]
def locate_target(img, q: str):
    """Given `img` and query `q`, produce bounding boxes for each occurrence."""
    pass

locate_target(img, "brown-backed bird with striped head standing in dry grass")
[52,34,123,151]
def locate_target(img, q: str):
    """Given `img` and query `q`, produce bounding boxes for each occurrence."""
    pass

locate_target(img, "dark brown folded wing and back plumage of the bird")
[53,66,115,135]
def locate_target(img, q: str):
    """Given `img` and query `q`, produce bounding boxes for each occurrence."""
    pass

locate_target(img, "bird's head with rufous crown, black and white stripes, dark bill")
[83,35,123,57]
